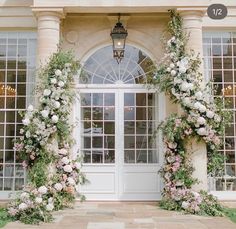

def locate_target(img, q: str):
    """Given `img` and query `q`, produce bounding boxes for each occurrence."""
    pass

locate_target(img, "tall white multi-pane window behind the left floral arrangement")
[0,32,36,191]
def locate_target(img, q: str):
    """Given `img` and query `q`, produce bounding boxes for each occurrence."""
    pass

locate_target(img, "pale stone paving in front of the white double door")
[4,202,236,229]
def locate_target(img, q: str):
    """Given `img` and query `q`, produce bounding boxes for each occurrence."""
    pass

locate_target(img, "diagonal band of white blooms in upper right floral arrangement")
[166,37,221,144]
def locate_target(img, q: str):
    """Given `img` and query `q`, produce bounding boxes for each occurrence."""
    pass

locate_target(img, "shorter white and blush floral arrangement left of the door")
[8,51,85,224]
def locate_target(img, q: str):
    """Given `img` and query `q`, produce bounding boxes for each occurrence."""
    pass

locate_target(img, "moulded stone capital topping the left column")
[32,7,65,19]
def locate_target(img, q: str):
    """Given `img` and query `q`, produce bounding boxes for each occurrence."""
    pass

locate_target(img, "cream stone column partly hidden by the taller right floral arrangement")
[179,9,207,191]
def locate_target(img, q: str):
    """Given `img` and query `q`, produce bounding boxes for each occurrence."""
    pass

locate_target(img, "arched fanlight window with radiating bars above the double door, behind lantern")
[79,45,154,84]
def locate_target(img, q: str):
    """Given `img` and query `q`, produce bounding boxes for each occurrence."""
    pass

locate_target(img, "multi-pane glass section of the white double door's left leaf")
[81,93,115,163]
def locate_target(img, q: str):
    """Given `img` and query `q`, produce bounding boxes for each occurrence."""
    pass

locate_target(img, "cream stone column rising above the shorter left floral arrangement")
[33,9,63,67]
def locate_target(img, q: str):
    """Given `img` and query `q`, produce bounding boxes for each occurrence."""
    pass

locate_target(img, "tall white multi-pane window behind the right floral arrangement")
[203,32,236,191]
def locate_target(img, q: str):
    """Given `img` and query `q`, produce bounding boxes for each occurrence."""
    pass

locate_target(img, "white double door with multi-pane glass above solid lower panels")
[77,89,160,200]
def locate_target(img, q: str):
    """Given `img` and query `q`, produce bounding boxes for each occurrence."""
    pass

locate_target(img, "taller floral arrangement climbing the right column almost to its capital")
[151,11,228,215]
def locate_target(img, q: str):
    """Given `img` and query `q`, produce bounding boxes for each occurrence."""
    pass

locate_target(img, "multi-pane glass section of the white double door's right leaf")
[124,93,157,163]
